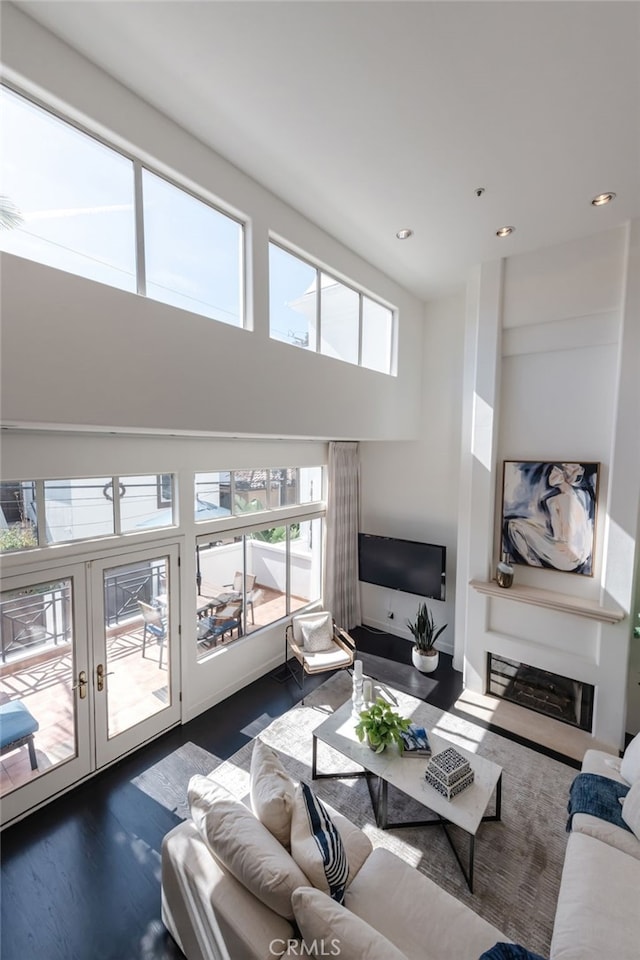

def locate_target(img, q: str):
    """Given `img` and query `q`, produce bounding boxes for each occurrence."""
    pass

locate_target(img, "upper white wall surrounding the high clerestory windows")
[0,6,423,439]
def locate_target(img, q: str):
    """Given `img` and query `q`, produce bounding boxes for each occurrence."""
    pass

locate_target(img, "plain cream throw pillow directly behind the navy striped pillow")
[249,737,296,850]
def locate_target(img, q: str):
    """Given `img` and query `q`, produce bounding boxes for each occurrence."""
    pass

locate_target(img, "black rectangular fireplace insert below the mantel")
[487,653,595,733]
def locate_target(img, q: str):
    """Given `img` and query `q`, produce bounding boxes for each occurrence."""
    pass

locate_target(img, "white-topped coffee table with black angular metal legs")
[311,686,502,892]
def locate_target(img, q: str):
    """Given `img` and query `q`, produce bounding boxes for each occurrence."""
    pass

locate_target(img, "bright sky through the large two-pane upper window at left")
[0,88,243,326]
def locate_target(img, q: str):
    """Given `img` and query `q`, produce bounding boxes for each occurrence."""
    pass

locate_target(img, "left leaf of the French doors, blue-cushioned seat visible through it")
[0,564,93,824]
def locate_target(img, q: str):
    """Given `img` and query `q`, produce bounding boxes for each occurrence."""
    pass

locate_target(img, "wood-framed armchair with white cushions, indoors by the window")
[284,610,356,703]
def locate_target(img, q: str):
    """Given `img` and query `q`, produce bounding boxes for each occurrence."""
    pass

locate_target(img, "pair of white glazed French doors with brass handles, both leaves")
[0,544,180,825]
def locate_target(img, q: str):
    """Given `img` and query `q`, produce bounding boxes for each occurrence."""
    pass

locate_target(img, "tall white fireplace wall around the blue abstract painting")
[456,223,640,748]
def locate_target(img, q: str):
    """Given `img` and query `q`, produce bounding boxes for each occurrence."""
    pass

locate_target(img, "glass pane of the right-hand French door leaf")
[102,557,171,739]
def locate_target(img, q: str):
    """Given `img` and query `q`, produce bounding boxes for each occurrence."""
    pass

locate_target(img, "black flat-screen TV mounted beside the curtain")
[358,533,447,600]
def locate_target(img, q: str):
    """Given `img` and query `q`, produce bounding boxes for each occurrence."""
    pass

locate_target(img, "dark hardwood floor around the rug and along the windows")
[0,627,462,960]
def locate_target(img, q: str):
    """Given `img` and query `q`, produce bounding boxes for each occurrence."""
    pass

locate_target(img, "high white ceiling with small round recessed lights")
[11,0,640,299]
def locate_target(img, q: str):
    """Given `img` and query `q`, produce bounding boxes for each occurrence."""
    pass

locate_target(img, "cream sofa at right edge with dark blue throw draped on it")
[551,741,640,960]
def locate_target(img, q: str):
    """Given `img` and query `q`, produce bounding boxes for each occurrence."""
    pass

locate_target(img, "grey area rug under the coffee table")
[211,673,576,956]
